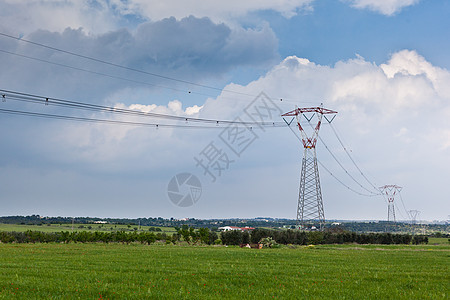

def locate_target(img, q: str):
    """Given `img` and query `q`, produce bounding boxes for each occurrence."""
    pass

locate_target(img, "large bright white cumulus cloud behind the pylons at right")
[192,50,450,218]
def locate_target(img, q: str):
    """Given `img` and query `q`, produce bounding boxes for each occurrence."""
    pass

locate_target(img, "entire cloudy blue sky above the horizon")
[0,0,450,221]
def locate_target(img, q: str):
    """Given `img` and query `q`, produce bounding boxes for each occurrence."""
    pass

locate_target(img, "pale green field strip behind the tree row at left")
[0,224,176,234]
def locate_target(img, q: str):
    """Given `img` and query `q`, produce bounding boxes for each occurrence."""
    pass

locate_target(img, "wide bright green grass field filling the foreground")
[0,244,450,299]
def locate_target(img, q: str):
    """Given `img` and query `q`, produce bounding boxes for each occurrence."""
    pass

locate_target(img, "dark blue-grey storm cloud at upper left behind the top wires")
[0,16,277,98]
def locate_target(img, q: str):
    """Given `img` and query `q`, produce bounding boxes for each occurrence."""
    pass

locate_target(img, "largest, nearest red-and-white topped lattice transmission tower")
[281,106,337,229]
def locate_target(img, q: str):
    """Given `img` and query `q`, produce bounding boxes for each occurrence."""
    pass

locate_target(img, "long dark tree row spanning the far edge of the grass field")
[0,225,428,245]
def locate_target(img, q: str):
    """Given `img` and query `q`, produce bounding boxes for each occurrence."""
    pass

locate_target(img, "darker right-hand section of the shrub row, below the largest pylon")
[221,229,428,245]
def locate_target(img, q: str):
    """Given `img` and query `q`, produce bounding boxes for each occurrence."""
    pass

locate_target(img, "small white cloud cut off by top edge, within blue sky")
[344,0,420,16]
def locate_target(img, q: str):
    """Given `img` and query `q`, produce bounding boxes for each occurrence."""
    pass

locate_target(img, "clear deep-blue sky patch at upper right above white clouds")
[270,1,450,67]
